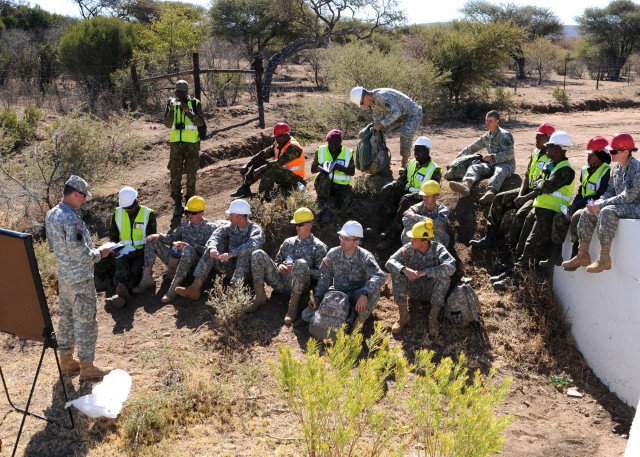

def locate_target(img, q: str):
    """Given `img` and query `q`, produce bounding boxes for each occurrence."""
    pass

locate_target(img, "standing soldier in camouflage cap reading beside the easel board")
[45,175,112,380]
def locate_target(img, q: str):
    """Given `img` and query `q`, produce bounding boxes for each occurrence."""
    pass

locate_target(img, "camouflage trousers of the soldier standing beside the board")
[56,278,98,362]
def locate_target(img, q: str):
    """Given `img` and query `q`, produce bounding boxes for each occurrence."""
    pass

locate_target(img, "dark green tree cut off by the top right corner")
[576,0,640,81]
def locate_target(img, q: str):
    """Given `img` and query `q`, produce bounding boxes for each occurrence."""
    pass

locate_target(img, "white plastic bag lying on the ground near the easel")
[64,370,131,419]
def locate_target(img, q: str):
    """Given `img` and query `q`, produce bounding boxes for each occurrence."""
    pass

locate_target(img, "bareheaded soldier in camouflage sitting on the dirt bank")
[449,111,516,204]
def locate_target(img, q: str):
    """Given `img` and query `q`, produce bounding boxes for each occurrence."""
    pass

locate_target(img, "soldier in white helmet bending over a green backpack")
[349,87,422,167]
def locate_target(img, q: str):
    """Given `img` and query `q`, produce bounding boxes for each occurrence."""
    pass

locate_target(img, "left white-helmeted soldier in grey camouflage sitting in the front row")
[176,200,264,300]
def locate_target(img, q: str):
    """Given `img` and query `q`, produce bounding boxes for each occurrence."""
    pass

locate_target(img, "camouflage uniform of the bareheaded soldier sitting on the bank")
[458,126,516,193]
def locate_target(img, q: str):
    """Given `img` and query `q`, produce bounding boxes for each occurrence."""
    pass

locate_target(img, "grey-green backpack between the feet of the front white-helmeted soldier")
[309,290,352,341]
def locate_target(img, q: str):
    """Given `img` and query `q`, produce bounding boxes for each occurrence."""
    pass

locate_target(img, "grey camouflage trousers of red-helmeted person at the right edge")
[578,203,640,244]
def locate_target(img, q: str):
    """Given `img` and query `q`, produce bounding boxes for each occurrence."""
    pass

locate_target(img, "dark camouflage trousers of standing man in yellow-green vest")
[167,142,200,202]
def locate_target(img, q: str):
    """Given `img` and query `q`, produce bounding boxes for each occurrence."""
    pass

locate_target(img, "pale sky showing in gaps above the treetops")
[29,0,610,25]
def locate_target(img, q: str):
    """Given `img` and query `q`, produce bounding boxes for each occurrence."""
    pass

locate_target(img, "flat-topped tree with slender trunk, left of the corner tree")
[461,0,562,79]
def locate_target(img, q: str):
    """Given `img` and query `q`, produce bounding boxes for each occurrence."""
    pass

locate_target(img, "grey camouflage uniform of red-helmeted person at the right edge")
[578,156,640,244]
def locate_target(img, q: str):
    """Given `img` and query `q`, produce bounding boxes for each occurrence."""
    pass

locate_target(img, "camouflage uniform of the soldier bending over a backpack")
[371,88,422,160]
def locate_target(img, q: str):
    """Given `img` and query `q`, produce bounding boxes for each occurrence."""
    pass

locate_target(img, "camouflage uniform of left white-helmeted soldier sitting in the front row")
[193,221,264,284]
